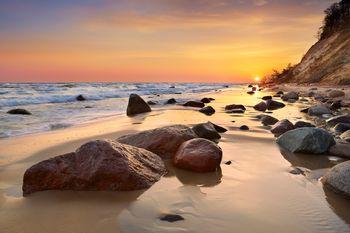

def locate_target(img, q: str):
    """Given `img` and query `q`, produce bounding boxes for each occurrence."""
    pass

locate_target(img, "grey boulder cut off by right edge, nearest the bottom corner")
[321,161,350,197]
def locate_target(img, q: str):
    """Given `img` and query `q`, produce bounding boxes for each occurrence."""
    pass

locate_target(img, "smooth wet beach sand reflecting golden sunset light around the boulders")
[0,88,350,233]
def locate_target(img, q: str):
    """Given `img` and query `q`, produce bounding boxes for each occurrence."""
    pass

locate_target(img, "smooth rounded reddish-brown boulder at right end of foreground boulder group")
[173,138,222,172]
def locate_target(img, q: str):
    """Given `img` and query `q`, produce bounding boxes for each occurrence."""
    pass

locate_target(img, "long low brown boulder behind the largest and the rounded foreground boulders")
[117,125,198,158]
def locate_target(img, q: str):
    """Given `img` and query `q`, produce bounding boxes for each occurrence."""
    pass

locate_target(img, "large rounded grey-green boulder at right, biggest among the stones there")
[277,128,335,154]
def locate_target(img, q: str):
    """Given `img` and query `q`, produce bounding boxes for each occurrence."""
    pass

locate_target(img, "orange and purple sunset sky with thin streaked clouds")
[0,0,335,82]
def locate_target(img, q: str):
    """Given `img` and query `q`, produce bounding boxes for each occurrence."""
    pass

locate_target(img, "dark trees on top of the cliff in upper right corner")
[319,0,350,40]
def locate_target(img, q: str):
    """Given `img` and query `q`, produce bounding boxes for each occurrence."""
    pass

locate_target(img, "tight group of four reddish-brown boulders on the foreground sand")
[22,122,226,195]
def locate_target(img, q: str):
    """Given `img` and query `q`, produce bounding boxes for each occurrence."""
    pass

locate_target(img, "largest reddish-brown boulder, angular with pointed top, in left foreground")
[22,140,166,195]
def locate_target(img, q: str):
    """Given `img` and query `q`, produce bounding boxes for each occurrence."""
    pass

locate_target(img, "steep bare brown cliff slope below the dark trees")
[288,29,350,85]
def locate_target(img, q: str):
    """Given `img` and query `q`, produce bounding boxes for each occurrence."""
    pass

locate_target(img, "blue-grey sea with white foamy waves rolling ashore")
[0,82,234,138]
